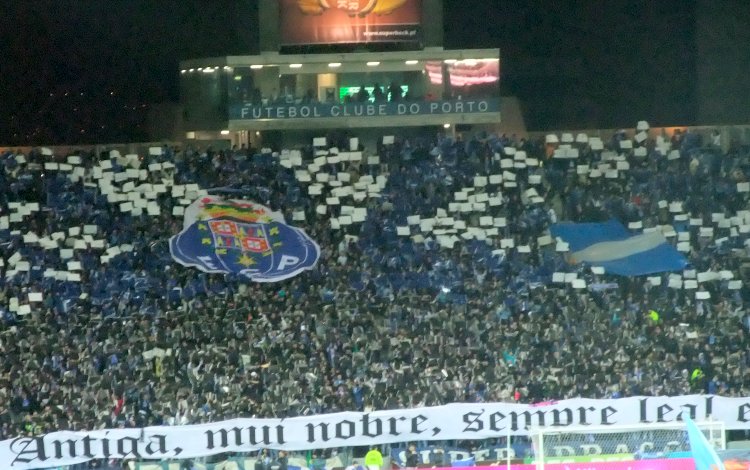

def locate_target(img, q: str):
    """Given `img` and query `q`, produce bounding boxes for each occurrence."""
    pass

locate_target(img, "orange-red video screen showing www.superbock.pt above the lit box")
[279,0,422,46]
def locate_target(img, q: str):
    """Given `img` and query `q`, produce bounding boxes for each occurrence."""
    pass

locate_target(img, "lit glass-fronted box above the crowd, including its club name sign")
[181,54,500,130]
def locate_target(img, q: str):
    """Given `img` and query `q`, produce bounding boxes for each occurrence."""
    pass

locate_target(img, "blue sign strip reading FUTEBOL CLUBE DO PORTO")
[229,98,500,120]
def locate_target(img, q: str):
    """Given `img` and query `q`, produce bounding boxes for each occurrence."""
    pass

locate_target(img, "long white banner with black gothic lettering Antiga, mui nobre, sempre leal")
[0,395,750,470]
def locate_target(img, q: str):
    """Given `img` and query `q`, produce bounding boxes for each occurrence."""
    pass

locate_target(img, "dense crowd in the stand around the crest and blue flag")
[0,123,750,446]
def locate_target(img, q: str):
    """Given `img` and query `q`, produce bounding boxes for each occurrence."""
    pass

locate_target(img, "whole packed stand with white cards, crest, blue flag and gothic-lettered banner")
[0,123,750,468]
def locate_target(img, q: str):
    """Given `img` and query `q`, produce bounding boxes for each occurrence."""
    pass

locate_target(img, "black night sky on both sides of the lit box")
[0,0,696,144]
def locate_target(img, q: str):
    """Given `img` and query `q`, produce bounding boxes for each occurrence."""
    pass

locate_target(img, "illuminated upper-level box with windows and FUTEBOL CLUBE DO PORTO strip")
[180,49,501,132]
